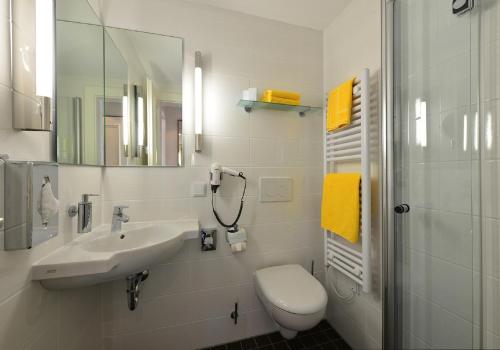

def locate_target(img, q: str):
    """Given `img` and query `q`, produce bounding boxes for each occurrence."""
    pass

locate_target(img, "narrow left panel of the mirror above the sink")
[56,20,104,165]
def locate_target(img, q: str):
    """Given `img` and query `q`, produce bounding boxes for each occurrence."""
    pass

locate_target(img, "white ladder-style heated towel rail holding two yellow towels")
[323,69,371,293]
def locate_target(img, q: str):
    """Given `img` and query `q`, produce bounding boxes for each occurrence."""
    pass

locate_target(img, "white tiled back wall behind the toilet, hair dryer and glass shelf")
[86,0,323,350]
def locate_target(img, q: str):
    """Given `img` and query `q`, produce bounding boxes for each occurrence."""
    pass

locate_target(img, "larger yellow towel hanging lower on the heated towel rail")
[321,173,361,243]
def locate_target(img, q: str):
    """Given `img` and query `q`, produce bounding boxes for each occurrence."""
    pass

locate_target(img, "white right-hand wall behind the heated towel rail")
[323,0,382,349]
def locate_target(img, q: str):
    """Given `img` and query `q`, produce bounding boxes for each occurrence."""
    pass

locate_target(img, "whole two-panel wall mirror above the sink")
[56,20,183,166]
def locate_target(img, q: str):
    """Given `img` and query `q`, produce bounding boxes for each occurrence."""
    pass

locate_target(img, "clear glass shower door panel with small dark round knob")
[393,0,481,349]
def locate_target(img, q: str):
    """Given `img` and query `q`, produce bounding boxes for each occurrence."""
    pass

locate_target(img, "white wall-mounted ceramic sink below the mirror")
[32,219,199,289]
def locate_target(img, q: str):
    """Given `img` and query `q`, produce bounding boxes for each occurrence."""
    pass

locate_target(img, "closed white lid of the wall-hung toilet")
[255,265,328,315]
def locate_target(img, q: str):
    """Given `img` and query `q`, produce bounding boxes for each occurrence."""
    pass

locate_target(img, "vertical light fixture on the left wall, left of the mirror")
[9,0,55,131]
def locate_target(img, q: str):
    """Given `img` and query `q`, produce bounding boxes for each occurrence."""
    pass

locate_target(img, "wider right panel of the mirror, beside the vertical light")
[104,28,182,166]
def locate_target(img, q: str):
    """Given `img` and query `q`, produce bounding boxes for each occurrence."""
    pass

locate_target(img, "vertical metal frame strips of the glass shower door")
[380,0,486,349]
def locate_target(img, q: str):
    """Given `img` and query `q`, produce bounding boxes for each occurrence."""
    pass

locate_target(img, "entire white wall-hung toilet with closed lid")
[254,265,328,339]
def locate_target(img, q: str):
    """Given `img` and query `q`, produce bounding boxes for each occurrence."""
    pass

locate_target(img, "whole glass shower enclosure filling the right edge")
[383,0,500,349]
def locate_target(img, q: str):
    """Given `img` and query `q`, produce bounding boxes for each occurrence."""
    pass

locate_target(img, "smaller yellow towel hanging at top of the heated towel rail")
[326,79,354,132]
